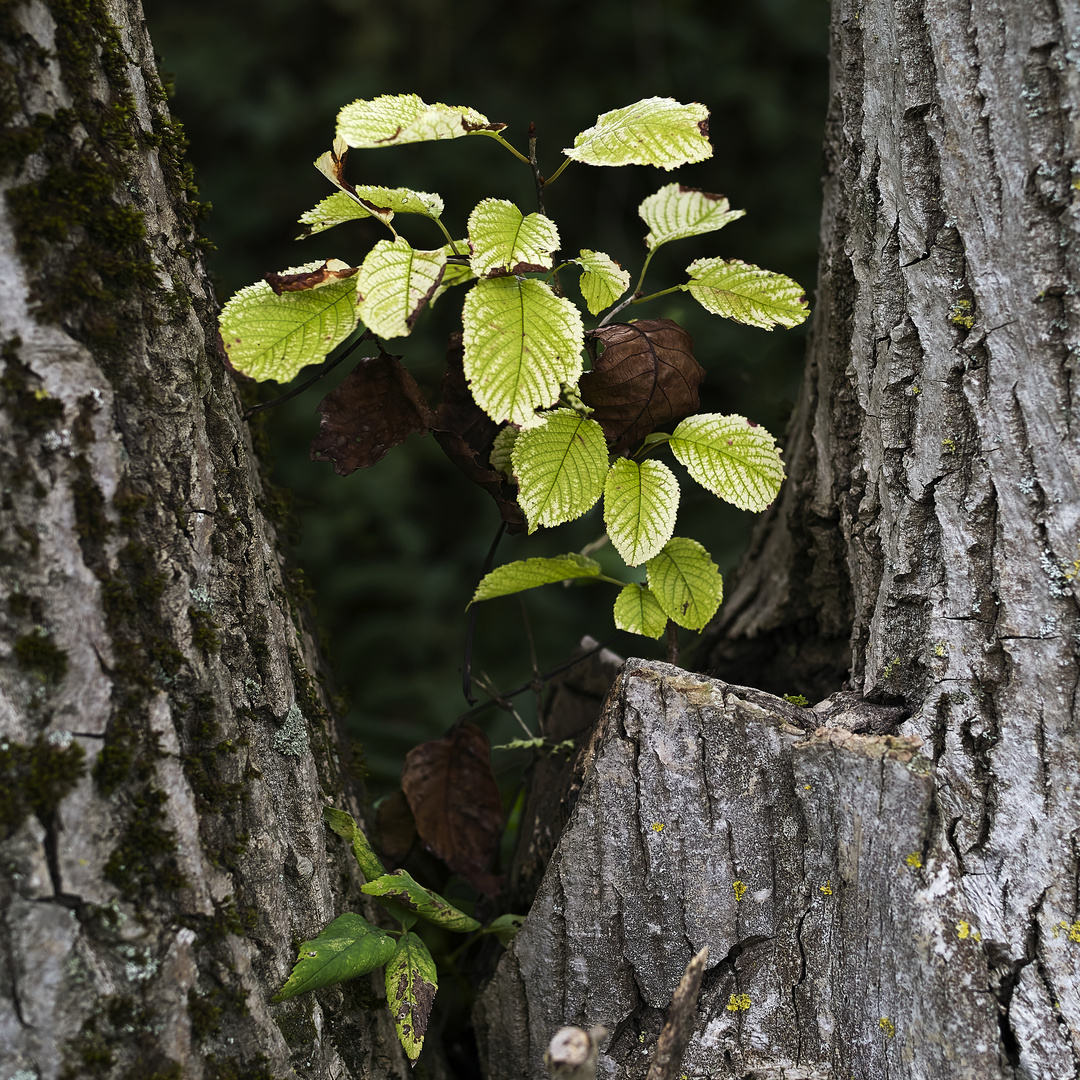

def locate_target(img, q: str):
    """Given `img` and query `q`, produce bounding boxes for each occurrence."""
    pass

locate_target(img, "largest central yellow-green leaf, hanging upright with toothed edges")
[461,278,584,424]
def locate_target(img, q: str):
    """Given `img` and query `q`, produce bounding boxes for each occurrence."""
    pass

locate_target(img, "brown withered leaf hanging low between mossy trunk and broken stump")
[402,724,502,895]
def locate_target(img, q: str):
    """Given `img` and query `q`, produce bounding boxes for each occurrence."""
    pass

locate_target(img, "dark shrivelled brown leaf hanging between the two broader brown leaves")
[431,332,526,532]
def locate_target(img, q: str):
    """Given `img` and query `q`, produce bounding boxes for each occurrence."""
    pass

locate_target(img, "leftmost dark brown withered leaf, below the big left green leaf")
[311,353,432,476]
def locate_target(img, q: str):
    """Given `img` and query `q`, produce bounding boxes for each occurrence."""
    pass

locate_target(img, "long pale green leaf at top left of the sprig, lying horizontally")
[337,94,507,150]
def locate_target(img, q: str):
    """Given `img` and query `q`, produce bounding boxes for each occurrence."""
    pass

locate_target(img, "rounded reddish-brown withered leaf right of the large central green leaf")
[579,319,705,454]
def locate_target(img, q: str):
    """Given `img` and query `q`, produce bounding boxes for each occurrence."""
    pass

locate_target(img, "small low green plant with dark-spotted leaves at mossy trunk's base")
[271,807,524,1064]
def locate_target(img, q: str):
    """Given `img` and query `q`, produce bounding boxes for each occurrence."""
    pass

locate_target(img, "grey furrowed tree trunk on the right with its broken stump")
[477,0,1080,1080]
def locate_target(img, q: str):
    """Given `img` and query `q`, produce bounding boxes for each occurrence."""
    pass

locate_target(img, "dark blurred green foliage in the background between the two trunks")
[145,0,828,792]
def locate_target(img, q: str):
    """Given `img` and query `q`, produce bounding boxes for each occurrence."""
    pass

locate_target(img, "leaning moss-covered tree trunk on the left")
[0,0,407,1080]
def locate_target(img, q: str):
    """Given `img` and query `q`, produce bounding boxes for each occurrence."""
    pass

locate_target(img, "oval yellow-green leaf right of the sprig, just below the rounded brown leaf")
[671,413,784,511]
